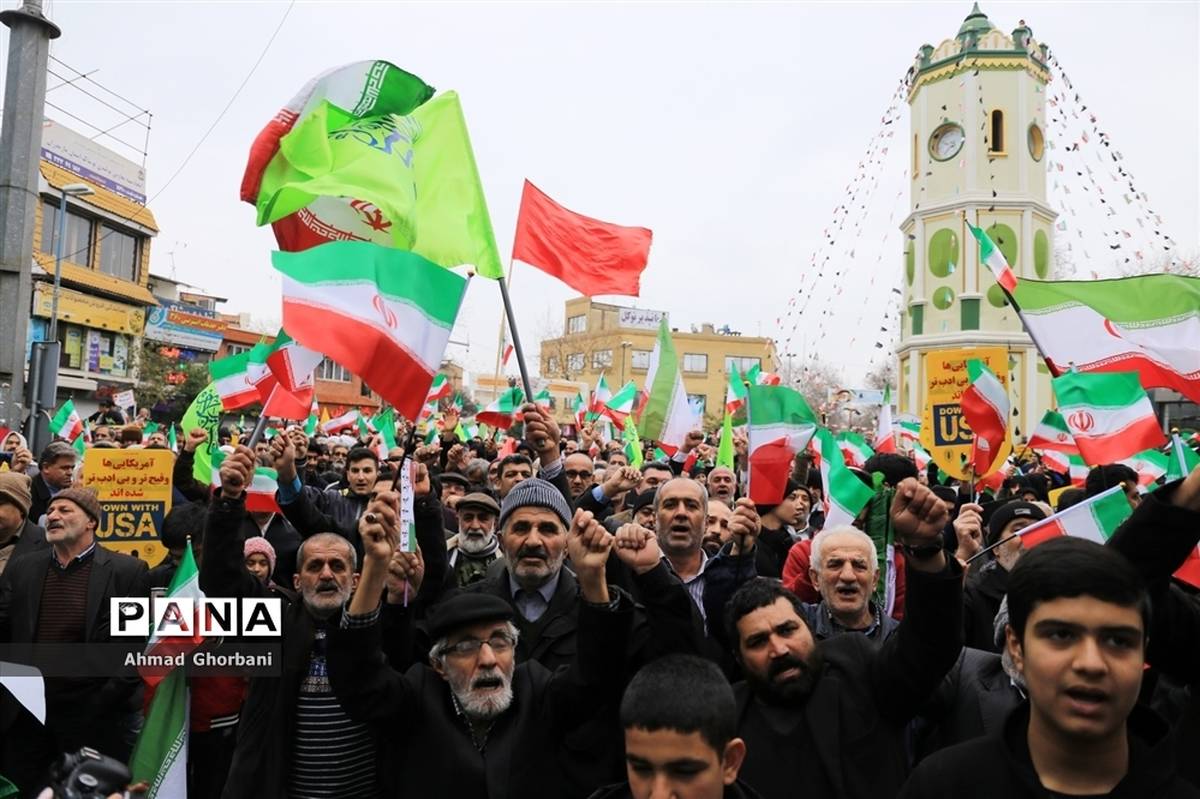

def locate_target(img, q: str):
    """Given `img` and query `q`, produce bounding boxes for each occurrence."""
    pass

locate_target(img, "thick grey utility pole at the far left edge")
[0,0,62,428]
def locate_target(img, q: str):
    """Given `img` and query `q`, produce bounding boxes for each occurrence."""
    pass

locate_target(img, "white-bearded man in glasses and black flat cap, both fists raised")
[329,486,634,799]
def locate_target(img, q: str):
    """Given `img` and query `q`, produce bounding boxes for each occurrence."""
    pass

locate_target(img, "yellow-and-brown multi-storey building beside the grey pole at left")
[26,120,158,416]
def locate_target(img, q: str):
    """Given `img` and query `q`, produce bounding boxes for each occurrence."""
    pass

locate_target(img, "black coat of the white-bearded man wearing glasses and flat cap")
[328,594,634,799]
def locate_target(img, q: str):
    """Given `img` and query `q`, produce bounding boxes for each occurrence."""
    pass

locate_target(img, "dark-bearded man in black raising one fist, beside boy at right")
[726,479,962,799]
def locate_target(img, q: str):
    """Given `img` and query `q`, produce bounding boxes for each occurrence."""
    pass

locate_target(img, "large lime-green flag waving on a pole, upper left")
[257,91,504,278]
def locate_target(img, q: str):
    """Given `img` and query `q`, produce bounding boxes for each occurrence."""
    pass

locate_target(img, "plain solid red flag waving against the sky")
[512,180,653,296]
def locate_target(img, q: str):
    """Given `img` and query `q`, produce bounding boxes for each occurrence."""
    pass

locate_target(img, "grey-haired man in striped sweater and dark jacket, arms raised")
[200,437,445,799]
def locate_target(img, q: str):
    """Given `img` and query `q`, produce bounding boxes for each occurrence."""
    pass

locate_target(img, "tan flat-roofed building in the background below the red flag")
[539,296,775,427]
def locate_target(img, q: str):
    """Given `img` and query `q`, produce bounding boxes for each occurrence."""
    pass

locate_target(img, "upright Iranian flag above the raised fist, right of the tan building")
[746,385,820,505]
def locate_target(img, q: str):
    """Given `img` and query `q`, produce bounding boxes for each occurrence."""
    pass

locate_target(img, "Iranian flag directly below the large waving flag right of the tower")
[1052,369,1166,465]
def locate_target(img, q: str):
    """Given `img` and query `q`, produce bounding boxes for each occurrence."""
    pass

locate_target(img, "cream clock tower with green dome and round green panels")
[896,5,1056,440]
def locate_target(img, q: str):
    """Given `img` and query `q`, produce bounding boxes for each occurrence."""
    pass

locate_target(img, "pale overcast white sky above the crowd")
[0,0,1200,382]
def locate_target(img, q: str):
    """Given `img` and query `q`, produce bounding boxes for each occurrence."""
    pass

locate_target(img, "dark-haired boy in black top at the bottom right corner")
[900,537,1200,799]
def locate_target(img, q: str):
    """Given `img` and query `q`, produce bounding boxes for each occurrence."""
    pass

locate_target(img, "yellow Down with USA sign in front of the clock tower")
[920,347,1013,480]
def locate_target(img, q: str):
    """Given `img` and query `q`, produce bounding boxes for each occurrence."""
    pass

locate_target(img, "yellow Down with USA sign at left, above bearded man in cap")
[83,449,175,566]
